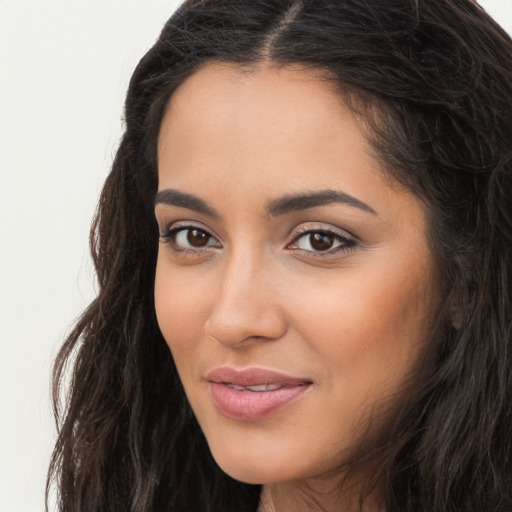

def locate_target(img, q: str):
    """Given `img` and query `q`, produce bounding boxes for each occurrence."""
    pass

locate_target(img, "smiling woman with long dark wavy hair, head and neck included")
[46,0,512,512]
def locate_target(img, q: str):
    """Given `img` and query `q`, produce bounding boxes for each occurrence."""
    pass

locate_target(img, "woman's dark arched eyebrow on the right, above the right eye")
[267,189,377,217]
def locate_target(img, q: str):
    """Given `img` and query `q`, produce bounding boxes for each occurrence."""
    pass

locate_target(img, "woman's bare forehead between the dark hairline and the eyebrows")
[158,63,421,231]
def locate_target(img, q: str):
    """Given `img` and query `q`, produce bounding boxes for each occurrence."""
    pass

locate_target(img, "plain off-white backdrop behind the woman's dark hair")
[0,0,512,512]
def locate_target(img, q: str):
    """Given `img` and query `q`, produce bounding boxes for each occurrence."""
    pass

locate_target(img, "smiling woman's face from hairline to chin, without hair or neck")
[155,63,435,483]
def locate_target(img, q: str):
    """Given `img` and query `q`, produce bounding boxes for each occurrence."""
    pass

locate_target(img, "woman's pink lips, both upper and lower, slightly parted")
[206,367,312,420]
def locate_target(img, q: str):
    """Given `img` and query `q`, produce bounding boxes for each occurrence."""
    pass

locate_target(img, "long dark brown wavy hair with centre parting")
[47,0,512,512]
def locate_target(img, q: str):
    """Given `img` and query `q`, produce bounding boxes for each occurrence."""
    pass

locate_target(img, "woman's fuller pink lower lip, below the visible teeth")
[210,382,310,420]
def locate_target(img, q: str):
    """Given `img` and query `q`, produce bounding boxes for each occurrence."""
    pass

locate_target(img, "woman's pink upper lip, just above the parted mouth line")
[206,366,311,386]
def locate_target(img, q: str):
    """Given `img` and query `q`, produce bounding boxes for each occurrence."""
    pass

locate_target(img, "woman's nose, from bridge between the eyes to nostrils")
[205,251,287,348]
